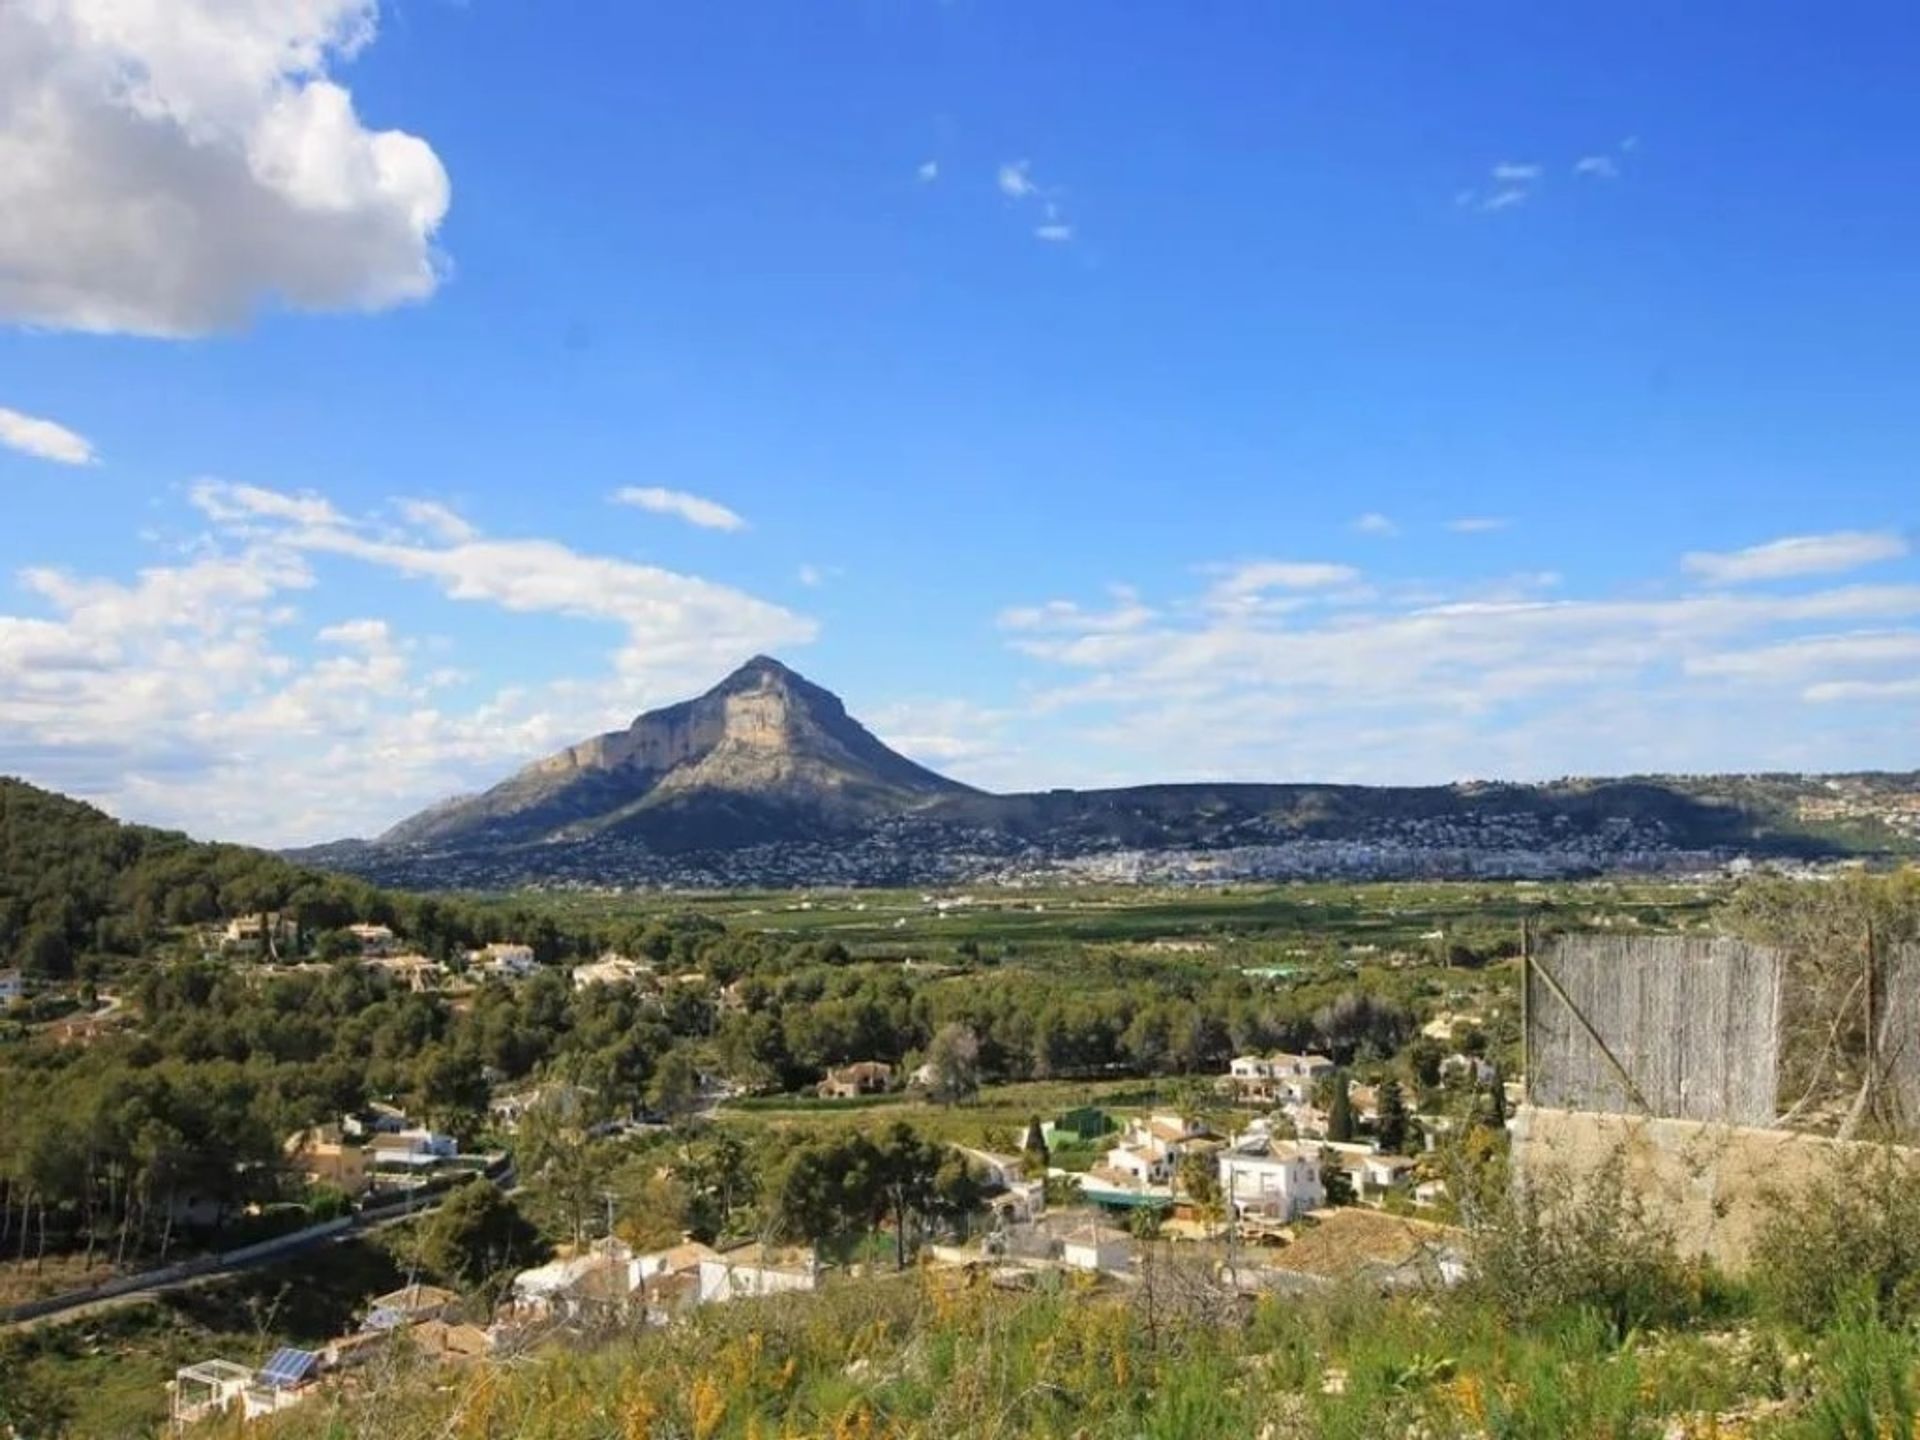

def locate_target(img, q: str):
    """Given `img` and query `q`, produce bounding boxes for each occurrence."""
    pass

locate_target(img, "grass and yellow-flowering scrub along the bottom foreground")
[236,1275,1920,1440]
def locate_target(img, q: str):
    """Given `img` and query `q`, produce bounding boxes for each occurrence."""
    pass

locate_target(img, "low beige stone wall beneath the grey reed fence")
[1513,1106,1904,1271]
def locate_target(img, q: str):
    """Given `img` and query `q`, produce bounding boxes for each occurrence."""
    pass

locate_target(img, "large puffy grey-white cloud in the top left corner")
[0,0,449,336]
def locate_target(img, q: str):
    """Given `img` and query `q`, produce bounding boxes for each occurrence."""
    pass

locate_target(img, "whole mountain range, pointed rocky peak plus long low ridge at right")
[318,655,1920,885]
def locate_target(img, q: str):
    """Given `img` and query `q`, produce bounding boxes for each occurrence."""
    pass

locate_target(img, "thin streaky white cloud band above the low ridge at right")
[1002,560,1920,783]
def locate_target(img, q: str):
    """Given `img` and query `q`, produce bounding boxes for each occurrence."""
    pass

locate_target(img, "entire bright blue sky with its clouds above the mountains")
[0,0,1920,843]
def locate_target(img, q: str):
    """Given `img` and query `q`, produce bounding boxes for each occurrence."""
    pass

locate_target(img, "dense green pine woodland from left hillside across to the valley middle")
[0,783,1466,1258]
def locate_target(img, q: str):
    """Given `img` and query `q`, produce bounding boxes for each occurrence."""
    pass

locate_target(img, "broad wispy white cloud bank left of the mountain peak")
[0,480,816,843]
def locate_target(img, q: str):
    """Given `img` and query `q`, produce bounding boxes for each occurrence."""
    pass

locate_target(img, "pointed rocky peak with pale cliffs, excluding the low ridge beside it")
[380,655,968,847]
